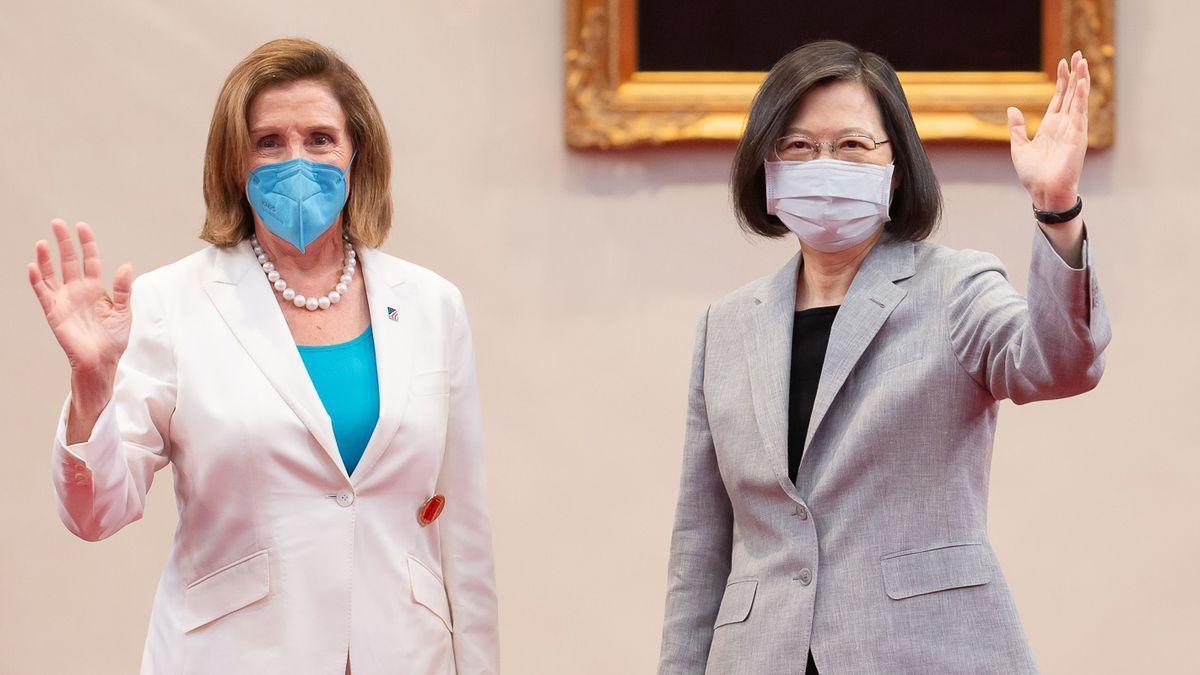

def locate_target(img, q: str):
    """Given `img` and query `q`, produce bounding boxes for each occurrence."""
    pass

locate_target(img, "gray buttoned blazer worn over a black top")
[659,229,1109,675]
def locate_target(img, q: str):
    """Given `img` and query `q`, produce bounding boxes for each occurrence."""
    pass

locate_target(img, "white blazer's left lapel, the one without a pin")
[204,241,346,477]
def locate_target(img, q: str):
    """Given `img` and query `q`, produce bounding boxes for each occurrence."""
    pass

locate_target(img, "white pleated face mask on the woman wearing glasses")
[767,160,895,253]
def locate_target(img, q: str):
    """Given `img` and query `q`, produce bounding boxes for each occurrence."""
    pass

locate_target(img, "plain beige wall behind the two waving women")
[0,0,1200,675]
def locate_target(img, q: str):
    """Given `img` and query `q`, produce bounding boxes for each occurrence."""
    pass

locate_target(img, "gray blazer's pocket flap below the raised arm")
[880,543,992,601]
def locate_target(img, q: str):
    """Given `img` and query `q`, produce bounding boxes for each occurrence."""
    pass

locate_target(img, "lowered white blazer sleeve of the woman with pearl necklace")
[438,293,499,675]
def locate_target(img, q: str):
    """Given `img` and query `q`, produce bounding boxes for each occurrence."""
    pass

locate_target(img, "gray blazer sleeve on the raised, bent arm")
[947,227,1111,404]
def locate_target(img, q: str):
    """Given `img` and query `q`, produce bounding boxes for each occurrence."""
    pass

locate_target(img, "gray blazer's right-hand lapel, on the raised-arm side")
[800,234,916,484]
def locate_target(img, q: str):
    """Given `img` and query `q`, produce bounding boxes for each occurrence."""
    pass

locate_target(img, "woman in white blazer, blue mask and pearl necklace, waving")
[29,40,498,675]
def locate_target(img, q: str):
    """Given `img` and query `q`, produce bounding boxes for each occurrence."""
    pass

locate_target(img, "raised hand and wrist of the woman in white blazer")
[29,219,133,431]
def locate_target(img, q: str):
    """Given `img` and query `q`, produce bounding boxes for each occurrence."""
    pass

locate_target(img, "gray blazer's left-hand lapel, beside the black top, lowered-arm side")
[743,253,800,498]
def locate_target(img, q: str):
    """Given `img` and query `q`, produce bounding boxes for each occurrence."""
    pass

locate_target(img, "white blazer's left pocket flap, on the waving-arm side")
[184,549,271,633]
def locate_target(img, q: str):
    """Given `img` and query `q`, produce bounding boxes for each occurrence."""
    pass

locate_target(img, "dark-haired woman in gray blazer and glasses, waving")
[659,42,1109,675]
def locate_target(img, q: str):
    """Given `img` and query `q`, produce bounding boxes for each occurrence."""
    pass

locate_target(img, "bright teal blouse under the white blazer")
[296,325,379,474]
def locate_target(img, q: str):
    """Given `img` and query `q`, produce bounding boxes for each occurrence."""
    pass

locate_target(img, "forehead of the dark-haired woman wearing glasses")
[787,80,883,136]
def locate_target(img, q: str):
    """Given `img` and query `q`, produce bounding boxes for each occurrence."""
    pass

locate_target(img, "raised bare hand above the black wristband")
[1008,52,1092,211]
